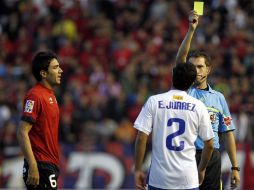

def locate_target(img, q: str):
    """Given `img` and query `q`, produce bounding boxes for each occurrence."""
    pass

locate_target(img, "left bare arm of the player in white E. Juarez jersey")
[135,131,148,189]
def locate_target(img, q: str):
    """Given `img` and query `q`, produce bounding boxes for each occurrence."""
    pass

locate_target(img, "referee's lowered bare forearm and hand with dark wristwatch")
[222,131,240,188]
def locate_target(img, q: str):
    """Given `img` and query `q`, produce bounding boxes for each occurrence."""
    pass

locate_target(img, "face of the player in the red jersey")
[46,59,63,86]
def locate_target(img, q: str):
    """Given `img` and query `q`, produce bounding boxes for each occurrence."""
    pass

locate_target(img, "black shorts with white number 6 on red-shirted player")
[23,160,59,190]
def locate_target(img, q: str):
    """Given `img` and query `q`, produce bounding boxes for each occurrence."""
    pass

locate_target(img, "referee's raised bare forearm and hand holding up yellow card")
[176,11,198,64]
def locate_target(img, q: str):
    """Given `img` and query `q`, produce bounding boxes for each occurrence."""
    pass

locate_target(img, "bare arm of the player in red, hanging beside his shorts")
[17,121,39,186]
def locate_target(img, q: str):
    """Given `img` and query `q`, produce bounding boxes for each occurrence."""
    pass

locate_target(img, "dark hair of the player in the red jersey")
[32,51,57,81]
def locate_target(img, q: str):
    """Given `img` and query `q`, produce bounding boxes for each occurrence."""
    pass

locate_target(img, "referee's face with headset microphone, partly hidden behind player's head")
[189,57,210,86]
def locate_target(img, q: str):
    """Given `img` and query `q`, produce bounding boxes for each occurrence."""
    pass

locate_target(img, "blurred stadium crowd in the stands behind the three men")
[0,0,254,188]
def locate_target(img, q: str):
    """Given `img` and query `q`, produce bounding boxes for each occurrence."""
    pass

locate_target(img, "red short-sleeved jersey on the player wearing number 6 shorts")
[21,83,59,166]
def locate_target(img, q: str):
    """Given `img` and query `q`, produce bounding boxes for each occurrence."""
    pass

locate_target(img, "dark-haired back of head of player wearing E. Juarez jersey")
[172,62,197,91]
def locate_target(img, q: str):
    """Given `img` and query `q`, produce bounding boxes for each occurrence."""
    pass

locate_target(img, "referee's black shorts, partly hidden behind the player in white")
[196,149,222,190]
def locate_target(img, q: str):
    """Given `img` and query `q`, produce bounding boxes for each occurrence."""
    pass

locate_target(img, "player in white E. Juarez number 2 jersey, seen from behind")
[134,63,214,190]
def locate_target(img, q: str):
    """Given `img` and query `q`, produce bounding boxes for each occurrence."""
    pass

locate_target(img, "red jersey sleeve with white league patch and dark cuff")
[21,94,41,124]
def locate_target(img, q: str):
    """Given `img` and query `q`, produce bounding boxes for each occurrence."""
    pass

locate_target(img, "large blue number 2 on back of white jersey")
[166,118,185,151]
